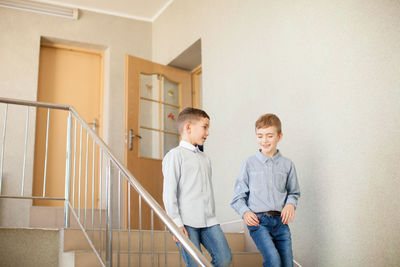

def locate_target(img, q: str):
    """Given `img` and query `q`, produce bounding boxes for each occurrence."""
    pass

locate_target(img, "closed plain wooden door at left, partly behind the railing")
[33,44,103,207]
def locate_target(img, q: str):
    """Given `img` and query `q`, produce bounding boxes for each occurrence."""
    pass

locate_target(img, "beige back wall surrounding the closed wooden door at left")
[0,7,152,226]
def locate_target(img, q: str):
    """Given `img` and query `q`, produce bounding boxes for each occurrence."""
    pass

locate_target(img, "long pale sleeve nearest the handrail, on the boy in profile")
[162,151,183,227]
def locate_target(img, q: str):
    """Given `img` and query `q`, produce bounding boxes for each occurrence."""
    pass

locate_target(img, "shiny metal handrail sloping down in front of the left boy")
[0,97,212,267]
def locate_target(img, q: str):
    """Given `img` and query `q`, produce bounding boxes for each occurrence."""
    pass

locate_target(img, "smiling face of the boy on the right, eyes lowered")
[256,126,282,157]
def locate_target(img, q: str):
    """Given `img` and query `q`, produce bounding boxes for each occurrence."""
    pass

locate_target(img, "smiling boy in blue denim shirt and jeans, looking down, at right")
[231,114,300,267]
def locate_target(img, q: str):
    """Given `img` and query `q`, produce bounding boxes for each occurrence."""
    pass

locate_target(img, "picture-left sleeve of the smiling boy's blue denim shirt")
[231,162,250,217]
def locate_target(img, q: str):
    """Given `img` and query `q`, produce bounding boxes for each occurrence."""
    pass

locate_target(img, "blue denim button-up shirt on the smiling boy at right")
[231,151,300,217]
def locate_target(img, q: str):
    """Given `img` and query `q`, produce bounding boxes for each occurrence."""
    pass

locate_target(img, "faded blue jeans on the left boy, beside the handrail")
[176,224,232,267]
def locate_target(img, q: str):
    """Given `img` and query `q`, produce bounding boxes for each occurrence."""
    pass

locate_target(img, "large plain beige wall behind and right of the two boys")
[153,0,400,266]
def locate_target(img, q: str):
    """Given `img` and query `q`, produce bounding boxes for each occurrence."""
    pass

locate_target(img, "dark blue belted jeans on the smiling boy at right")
[247,214,293,267]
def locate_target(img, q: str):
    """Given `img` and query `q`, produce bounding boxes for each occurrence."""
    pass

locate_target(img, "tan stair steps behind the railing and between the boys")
[63,229,262,267]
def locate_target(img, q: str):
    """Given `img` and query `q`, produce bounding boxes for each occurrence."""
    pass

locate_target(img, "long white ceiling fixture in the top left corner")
[0,0,79,20]
